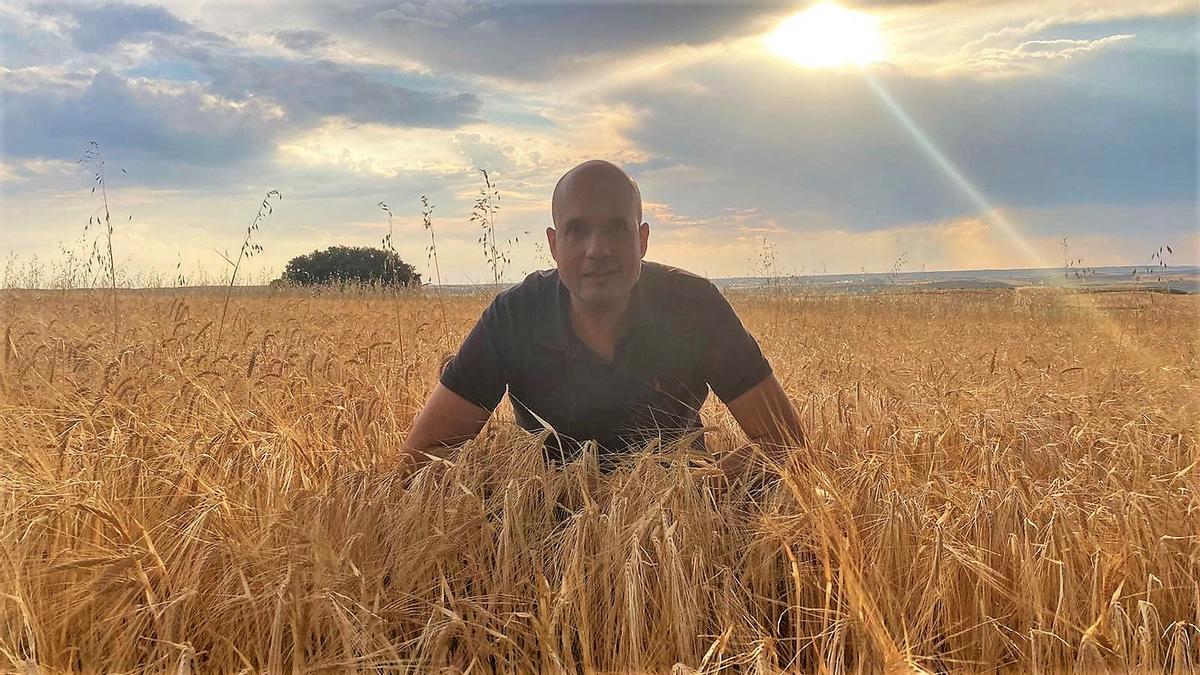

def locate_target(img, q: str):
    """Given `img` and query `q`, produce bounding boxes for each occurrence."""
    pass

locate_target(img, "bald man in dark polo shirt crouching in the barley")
[402,160,803,478]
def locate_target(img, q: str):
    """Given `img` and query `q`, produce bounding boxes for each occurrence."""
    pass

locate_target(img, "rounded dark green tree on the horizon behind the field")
[283,246,421,286]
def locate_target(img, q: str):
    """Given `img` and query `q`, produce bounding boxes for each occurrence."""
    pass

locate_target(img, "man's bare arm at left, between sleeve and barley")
[398,382,492,474]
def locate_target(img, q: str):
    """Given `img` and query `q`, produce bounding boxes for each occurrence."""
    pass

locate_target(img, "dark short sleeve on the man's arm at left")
[440,301,508,411]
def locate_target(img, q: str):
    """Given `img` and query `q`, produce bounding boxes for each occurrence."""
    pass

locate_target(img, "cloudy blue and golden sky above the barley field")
[0,0,1200,283]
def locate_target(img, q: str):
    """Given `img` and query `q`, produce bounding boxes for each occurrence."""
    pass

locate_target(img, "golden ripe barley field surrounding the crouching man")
[0,288,1200,674]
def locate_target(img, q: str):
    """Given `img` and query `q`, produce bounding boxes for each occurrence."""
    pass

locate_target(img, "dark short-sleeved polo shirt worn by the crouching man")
[442,257,770,470]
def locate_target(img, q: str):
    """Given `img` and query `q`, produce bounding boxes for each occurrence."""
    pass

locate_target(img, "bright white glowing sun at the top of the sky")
[763,2,883,68]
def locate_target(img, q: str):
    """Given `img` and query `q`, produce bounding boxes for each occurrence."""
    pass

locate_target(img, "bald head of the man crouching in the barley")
[546,160,650,306]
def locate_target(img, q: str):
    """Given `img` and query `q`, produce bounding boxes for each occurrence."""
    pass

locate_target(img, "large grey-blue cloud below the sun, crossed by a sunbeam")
[596,35,1198,229]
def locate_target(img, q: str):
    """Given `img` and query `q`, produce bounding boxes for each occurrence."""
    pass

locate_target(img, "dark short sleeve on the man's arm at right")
[700,282,772,404]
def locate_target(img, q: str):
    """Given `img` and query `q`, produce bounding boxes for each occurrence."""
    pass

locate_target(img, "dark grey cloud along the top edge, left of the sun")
[307,0,796,80]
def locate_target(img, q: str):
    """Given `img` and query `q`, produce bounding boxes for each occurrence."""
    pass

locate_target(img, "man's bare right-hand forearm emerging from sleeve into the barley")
[718,374,804,478]
